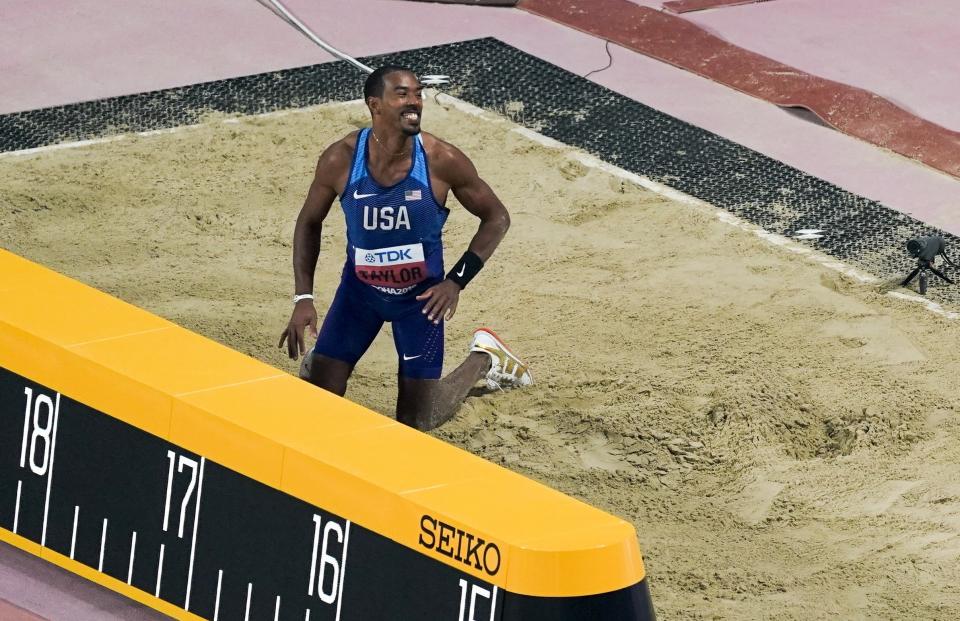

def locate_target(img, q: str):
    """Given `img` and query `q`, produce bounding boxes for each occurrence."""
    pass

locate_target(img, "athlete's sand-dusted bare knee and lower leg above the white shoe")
[397,352,490,431]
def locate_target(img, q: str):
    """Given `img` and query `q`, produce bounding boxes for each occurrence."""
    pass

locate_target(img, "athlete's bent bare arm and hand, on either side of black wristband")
[417,134,510,323]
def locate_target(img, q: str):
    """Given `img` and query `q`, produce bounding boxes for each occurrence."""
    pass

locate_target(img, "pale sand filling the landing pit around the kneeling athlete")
[0,101,960,619]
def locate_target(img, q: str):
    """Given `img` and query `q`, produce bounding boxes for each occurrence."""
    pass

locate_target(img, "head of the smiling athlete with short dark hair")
[363,65,423,136]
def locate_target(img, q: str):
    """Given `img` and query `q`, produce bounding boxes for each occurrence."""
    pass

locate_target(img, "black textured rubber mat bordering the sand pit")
[0,38,960,306]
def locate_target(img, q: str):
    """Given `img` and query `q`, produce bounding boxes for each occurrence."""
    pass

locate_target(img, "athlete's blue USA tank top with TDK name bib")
[340,128,450,299]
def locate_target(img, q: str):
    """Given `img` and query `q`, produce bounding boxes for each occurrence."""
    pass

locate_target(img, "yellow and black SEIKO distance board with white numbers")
[0,250,653,621]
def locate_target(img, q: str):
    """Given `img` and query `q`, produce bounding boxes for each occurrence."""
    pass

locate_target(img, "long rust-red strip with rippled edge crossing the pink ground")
[518,0,960,177]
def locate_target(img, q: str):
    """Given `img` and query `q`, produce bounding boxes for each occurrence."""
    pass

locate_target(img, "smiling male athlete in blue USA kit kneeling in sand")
[280,66,533,430]
